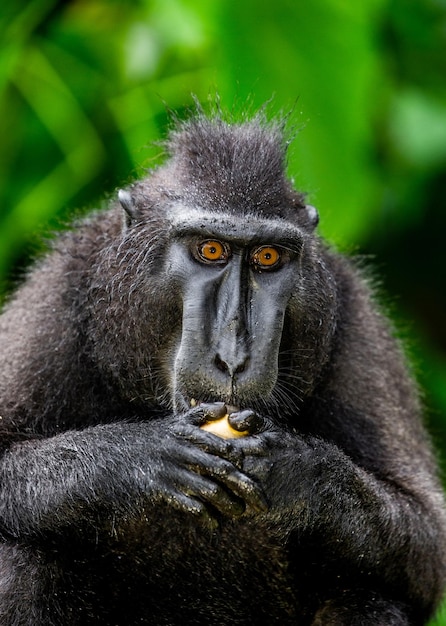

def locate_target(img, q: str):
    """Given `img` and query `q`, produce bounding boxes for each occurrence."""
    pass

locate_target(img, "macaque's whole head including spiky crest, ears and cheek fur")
[89,117,335,420]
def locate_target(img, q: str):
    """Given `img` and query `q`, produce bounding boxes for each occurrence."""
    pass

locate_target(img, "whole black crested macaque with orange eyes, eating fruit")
[0,113,446,626]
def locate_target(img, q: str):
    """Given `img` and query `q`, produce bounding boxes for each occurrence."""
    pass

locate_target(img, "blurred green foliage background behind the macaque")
[0,0,446,626]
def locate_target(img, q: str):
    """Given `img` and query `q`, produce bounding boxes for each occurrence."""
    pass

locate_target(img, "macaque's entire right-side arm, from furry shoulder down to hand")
[240,302,446,615]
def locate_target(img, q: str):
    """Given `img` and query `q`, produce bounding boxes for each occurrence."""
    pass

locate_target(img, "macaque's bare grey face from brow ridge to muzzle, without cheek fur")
[166,207,310,410]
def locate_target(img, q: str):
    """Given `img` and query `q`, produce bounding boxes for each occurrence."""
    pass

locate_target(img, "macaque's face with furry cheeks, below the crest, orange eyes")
[88,205,336,417]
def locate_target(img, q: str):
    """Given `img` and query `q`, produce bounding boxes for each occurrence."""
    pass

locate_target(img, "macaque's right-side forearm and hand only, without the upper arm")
[251,424,446,607]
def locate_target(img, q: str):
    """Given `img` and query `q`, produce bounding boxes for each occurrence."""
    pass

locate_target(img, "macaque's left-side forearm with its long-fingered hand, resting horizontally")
[0,420,264,540]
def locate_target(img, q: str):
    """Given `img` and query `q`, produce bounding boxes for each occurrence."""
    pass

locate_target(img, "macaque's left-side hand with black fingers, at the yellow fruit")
[159,402,267,522]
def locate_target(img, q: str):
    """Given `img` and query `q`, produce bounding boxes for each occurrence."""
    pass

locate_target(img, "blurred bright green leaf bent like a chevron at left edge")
[0,43,105,276]
